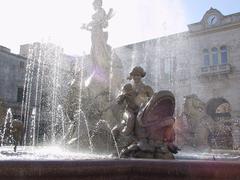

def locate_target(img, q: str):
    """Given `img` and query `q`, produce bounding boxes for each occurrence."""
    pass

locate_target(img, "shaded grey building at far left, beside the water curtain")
[0,46,27,118]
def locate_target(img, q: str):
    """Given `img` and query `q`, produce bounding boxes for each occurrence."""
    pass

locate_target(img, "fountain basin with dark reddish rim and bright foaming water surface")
[0,147,240,180]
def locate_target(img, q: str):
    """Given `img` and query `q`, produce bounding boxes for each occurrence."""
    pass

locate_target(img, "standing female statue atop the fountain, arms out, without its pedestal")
[82,0,113,74]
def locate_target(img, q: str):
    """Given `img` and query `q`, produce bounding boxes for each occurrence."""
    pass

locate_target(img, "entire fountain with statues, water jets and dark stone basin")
[0,0,240,179]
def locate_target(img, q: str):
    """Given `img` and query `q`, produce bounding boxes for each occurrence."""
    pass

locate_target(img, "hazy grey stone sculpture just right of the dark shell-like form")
[176,94,214,151]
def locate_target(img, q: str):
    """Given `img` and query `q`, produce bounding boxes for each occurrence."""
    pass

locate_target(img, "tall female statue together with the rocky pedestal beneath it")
[65,0,123,148]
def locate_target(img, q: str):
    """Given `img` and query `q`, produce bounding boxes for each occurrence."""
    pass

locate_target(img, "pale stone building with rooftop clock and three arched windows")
[115,8,240,116]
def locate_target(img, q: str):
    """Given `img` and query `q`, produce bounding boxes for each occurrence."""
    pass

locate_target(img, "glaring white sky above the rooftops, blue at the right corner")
[0,0,240,55]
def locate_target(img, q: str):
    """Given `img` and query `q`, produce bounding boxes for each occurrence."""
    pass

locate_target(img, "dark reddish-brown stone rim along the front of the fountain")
[0,159,240,179]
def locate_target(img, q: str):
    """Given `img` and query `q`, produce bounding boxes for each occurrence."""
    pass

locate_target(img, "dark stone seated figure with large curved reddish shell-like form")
[112,66,178,159]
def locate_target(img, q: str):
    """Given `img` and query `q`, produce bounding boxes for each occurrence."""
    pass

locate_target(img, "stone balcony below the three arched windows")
[201,64,231,76]
